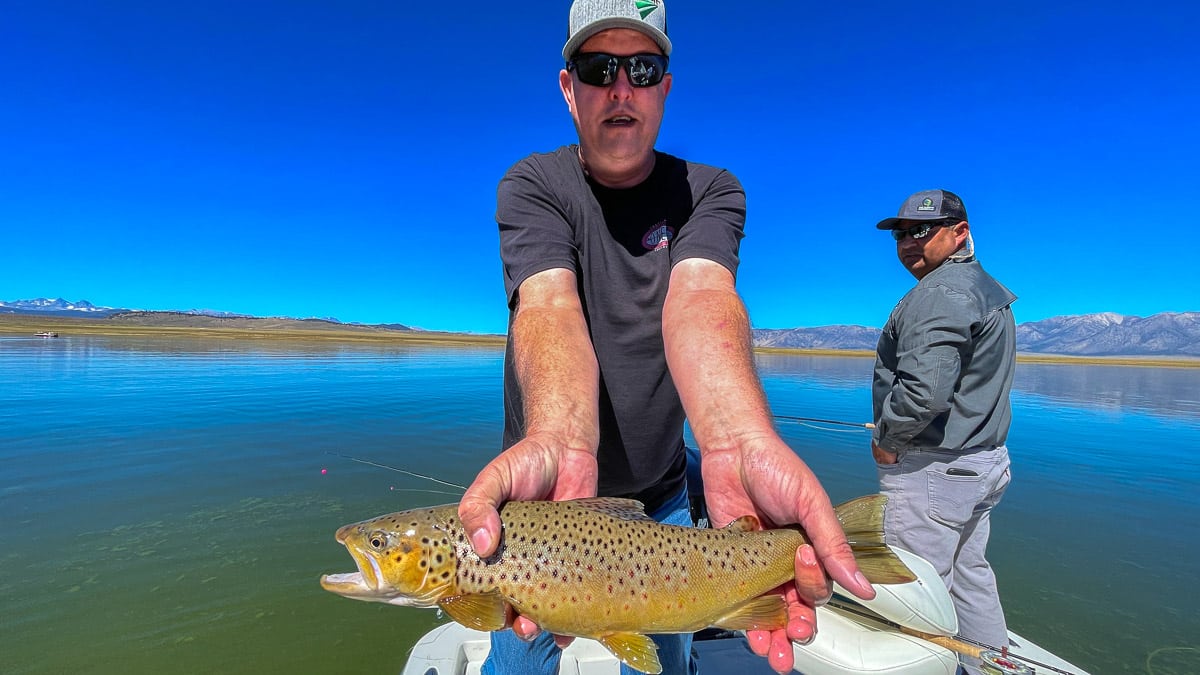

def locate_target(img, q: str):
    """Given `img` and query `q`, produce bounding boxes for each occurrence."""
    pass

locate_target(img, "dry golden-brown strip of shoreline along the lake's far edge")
[0,313,1200,368]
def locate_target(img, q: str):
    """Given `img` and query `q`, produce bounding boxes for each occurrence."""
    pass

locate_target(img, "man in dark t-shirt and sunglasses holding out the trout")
[458,0,875,674]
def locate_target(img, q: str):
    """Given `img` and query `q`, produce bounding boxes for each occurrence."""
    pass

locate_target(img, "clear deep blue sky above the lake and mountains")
[0,0,1200,333]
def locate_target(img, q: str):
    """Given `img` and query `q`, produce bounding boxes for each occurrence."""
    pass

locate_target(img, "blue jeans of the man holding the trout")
[480,489,700,675]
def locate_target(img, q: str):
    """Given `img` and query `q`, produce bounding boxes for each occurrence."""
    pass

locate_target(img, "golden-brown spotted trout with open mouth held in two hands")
[320,495,914,673]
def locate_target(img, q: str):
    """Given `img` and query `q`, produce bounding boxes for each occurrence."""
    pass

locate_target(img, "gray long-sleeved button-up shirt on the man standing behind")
[871,257,1016,453]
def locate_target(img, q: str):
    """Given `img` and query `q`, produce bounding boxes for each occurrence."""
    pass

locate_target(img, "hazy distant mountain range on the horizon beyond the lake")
[0,298,1200,357]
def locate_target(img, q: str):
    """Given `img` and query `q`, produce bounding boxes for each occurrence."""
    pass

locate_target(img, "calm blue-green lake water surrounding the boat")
[0,338,1200,675]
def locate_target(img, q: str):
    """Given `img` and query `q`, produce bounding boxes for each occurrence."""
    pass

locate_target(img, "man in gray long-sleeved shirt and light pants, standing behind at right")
[871,190,1016,665]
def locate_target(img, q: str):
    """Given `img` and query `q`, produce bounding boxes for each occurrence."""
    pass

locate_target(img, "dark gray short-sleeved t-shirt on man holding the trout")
[496,145,745,512]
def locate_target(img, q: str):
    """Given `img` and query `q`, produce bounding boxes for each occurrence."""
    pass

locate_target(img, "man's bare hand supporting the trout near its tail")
[701,434,875,673]
